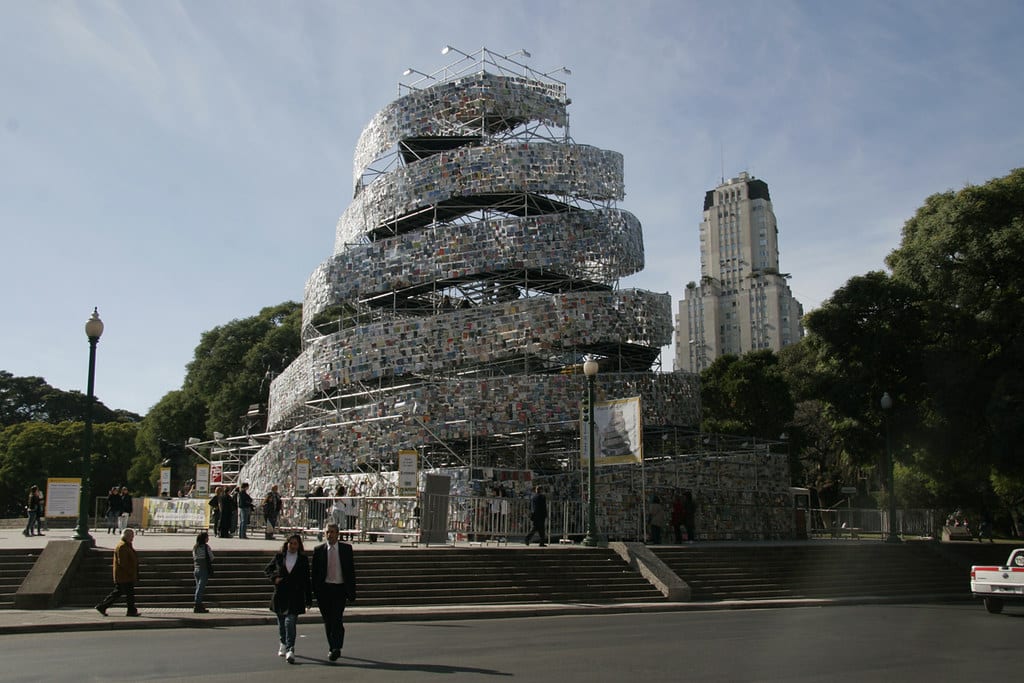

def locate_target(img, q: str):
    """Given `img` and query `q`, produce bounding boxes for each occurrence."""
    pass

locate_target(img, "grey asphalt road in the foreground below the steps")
[0,604,1024,683]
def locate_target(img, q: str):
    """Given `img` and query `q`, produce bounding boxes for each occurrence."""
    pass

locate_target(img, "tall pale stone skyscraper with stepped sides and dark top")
[675,172,804,373]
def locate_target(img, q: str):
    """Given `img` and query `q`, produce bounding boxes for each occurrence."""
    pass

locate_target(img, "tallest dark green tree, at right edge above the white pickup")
[887,169,1024,505]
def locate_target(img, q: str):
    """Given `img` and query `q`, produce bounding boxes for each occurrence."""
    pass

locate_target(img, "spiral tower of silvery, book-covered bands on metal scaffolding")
[243,48,698,489]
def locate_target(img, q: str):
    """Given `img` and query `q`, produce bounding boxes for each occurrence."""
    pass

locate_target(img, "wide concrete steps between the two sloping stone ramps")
[63,548,665,607]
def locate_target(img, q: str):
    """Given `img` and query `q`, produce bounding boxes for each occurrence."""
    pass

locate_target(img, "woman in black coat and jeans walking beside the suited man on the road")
[263,533,313,664]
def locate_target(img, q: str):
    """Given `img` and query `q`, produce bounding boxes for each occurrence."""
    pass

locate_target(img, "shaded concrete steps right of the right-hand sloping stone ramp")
[652,542,1010,601]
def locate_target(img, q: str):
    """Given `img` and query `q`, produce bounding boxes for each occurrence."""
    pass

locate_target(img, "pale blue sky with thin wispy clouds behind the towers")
[0,0,1024,414]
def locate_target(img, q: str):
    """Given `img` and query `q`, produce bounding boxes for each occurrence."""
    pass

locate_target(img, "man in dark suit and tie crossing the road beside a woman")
[313,522,355,661]
